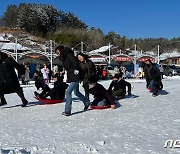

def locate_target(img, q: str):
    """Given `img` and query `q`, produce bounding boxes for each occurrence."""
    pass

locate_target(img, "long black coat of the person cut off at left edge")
[0,57,24,94]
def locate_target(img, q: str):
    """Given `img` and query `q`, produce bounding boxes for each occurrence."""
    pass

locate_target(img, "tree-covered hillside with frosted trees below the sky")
[0,3,180,53]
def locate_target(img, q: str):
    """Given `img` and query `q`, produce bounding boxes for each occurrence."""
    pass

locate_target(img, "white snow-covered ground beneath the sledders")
[0,77,180,154]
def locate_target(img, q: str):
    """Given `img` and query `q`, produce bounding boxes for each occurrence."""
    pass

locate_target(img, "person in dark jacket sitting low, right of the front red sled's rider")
[108,72,131,99]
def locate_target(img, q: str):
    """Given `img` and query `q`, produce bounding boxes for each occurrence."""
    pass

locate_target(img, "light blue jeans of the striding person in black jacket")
[65,81,90,113]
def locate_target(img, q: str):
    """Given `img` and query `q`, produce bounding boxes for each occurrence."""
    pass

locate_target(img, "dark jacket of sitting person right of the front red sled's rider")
[108,79,131,93]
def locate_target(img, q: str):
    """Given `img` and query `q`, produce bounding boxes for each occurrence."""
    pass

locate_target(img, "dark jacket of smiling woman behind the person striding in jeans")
[79,60,96,84]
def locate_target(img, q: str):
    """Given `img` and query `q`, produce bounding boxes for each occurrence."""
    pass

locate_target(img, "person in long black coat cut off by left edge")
[0,52,28,107]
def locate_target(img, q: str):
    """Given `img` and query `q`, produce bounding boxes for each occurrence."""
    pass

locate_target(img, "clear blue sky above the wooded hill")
[0,0,180,39]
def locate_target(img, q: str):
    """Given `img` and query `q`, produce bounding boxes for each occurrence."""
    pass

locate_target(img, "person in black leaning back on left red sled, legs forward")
[34,73,68,100]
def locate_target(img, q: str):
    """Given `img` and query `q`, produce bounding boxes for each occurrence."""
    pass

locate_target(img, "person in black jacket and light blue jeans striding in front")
[55,46,90,116]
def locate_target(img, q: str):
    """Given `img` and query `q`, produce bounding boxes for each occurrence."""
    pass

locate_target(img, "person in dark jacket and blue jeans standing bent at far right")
[144,59,163,97]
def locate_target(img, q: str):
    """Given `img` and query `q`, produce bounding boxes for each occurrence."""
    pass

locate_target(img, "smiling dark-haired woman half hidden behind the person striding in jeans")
[77,52,96,99]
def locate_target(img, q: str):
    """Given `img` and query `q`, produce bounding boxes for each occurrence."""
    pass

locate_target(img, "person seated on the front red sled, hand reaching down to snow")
[89,77,116,109]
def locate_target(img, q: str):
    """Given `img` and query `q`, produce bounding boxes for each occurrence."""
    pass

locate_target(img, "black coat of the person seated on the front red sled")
[89,83,114,105]
